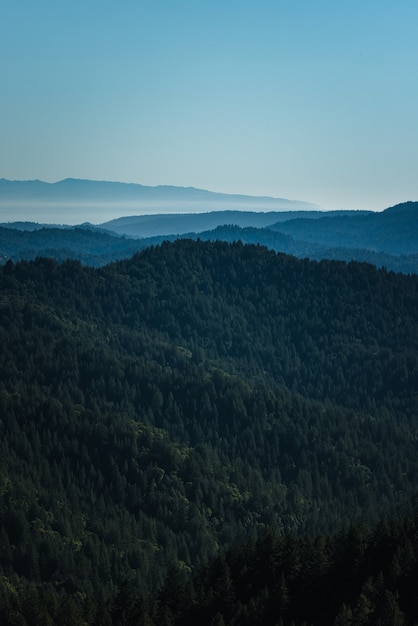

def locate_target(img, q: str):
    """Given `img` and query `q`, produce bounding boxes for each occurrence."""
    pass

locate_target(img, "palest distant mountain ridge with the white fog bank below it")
[0,178,318,224]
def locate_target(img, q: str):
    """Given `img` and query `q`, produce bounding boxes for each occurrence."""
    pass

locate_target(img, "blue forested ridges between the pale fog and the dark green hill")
[0,197,418,273]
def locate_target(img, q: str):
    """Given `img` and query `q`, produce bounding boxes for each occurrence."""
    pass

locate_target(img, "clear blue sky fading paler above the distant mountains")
[0,0,418,210]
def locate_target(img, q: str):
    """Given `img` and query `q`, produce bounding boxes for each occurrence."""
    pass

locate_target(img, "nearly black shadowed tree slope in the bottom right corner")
[114,518,418,626]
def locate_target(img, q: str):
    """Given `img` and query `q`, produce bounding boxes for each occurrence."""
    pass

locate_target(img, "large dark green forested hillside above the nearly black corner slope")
[0,240,418,626]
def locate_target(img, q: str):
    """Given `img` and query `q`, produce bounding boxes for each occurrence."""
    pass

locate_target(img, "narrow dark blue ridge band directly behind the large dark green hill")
[0,223,418,274]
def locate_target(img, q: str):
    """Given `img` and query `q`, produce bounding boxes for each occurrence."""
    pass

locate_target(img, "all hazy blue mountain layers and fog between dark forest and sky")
[0,179,418,273]
